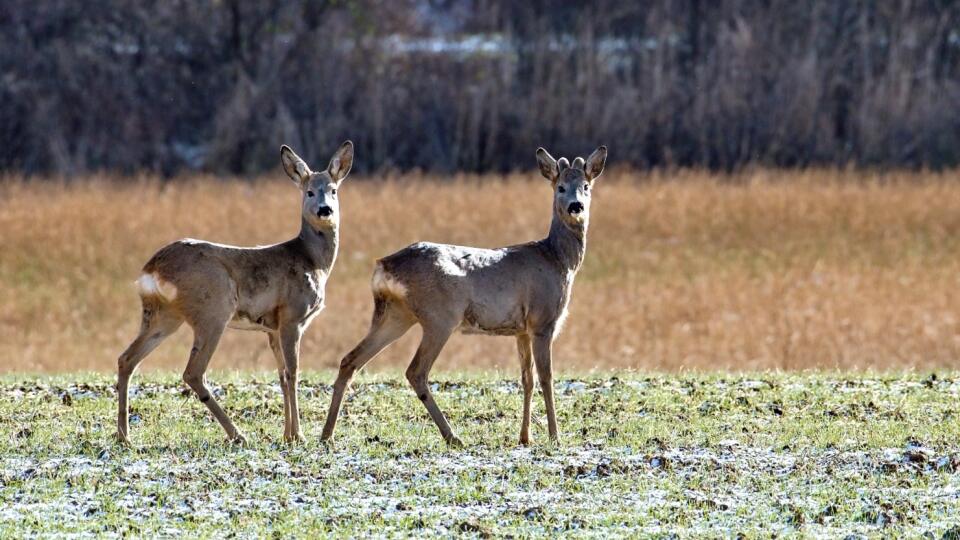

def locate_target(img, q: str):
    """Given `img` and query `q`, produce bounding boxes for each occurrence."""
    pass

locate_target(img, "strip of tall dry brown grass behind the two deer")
[0,170,960,372]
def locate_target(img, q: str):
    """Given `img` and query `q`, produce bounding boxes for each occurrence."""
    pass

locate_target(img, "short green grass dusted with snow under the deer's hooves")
[0,373,960,538]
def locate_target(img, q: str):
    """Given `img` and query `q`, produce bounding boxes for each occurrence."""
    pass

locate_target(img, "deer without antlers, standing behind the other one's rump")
[117,141,353,444]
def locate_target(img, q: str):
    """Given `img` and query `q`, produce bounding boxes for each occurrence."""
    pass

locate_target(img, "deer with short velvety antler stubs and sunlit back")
[321,146,607,447]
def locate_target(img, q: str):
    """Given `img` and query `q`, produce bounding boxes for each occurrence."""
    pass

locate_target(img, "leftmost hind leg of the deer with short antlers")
[320,298,413,441]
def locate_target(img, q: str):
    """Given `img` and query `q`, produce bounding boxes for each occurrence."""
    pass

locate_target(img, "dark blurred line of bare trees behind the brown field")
[0,0,960,175]
